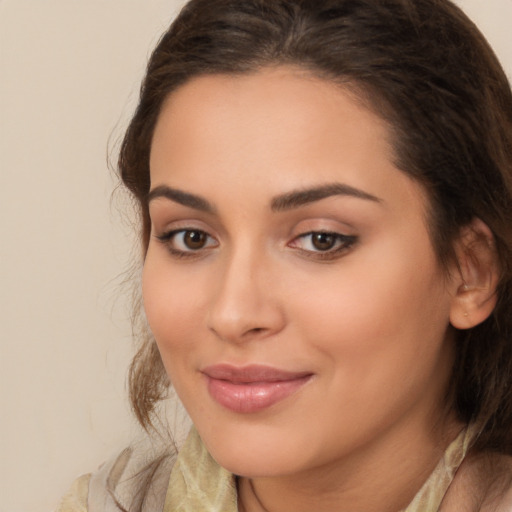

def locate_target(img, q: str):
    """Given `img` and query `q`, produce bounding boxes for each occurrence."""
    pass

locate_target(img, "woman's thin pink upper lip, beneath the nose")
[201,364,312,384]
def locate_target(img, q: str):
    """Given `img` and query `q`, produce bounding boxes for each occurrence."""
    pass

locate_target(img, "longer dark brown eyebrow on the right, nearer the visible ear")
[270,183,382,212]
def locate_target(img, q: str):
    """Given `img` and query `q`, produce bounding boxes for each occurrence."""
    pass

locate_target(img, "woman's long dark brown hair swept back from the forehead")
[119,0,512,453]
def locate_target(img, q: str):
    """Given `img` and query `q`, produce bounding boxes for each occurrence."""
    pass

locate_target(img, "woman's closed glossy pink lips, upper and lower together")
[201,364,313,413]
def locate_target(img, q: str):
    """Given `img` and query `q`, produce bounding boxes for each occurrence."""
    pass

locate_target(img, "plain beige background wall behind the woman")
[0,0,512,512]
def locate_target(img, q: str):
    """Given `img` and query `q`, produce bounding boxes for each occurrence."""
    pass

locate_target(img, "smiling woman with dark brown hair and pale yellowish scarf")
[61,0,512,512]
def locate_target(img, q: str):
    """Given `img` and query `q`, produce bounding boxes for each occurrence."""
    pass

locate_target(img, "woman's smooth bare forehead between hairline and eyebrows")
[150,67,428,220]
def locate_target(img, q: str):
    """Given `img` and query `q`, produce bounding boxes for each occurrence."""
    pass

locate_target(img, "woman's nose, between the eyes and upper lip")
[207,248,285,343]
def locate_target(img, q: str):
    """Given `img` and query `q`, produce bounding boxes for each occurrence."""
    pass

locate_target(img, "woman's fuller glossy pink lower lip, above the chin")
[208,375,311,413]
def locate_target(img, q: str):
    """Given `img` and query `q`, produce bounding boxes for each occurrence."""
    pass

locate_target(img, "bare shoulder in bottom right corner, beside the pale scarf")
[440,453,512,512]
